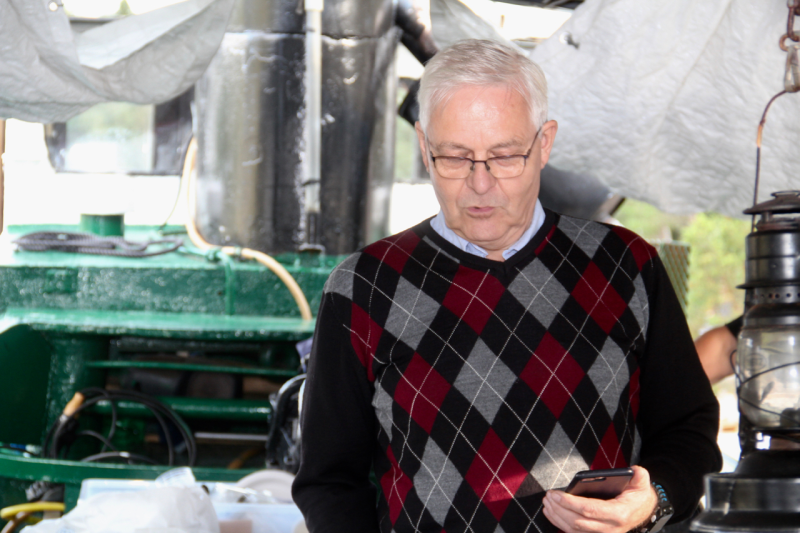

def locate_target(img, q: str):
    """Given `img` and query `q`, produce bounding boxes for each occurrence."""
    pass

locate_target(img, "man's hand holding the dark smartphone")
[544,466,658,533]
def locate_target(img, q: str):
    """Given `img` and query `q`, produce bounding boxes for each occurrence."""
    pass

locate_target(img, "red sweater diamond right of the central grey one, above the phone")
[519,332,585,418]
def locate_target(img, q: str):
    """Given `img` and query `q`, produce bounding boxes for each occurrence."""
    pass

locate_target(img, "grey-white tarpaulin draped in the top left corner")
[0,0,234,122]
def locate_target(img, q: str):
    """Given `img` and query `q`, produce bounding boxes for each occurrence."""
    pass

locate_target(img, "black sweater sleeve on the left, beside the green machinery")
[292,293,378,533]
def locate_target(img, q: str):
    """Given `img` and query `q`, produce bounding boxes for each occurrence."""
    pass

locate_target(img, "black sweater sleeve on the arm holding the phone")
[638,256,722,523]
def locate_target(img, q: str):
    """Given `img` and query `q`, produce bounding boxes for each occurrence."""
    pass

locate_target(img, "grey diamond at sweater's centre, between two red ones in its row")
[455,339,516,424]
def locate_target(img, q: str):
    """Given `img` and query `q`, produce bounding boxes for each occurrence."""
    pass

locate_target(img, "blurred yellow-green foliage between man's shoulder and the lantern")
[614,199,750,338]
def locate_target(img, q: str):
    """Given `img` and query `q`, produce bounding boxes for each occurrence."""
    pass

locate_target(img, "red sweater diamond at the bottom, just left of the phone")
[464,429,528,520]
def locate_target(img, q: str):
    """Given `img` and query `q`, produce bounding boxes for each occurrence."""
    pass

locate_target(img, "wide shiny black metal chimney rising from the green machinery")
[194,0,400,255]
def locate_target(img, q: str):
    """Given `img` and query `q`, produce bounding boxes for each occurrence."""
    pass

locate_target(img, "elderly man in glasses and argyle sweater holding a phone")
[294,41,720,533]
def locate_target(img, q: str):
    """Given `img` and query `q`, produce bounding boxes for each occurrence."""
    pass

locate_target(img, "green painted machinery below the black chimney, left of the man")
[0,222,342,508]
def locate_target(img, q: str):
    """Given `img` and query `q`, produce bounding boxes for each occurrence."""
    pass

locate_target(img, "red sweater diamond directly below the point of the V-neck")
[442,266,505,334]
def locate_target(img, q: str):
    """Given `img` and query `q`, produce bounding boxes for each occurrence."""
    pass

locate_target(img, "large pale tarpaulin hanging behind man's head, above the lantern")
[531,0,800,216]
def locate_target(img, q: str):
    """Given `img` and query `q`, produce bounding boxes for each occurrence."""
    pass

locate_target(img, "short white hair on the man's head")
[418,39,547,131]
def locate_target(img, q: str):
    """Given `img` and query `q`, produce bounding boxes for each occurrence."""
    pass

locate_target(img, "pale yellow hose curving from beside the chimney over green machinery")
[181,137,312,320]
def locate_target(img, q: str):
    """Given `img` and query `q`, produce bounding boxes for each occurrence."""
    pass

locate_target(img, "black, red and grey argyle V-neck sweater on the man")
[294,211,721,533]
